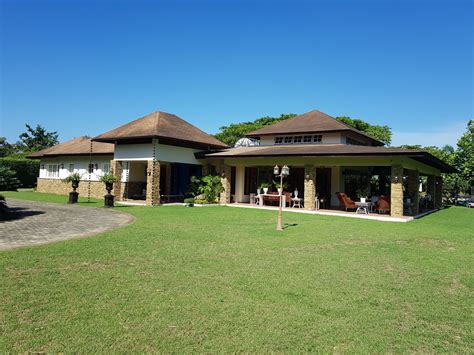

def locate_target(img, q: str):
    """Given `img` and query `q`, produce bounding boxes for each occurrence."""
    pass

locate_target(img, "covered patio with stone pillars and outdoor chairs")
[202,146,450,218]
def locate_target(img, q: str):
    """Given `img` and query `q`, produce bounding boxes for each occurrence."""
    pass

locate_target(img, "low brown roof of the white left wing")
[27,136,114,159]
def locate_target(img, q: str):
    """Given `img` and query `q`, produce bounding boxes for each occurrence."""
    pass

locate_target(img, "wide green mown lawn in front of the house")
[0,192,474,353]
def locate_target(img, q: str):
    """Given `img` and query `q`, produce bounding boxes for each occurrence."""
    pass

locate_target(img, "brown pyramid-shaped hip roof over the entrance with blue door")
[93,111,227,148]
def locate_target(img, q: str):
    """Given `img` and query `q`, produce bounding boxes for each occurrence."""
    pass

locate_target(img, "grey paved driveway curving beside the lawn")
[0,198,133,250]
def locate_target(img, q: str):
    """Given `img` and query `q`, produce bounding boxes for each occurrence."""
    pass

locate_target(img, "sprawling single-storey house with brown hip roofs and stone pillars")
[27,110,455,217]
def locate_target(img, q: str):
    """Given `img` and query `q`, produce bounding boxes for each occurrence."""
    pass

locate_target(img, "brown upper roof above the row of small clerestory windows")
[247,110,383,145]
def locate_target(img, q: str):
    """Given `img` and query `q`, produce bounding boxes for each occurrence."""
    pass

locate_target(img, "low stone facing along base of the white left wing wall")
[36,178,107,199]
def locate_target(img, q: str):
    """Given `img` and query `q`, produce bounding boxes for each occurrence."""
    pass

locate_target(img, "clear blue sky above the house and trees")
[0,0,474,145]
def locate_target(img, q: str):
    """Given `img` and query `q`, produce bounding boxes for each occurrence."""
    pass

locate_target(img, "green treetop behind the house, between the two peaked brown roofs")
[214,113,296,147]
